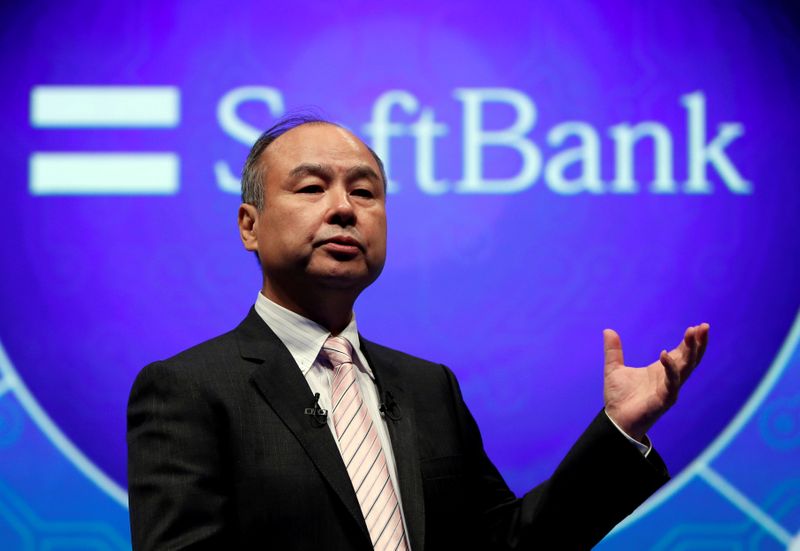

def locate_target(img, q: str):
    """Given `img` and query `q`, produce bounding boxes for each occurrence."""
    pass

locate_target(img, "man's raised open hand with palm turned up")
[603,323,709,441]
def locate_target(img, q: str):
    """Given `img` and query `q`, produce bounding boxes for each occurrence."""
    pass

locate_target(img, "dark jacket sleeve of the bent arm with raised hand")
[445,368,669,550]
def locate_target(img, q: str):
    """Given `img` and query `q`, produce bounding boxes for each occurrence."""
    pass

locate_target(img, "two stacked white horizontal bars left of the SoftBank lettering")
[28,86,180,195]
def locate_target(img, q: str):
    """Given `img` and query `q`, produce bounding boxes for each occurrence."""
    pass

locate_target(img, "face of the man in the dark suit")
[254,124,386,300]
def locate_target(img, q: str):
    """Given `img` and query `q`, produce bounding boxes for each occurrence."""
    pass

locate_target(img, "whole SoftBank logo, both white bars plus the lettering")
[29,86,753,195]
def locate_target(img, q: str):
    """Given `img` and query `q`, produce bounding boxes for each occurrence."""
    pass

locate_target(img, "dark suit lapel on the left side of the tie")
[236,308,370,543]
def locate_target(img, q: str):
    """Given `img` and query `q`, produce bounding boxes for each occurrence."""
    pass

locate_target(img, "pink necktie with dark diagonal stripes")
[322,337,408,551]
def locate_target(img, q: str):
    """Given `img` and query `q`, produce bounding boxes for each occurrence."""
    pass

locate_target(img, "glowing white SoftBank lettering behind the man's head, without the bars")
[215,87,752,195]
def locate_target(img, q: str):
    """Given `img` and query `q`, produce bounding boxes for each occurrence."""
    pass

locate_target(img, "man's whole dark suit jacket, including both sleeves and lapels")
[128,309,667,551]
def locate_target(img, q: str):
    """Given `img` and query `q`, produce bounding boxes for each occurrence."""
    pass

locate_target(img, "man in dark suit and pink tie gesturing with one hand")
[128,114,708,551]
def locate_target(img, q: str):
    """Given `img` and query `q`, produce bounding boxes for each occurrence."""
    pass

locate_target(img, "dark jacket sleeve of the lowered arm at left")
[127,363,230,551]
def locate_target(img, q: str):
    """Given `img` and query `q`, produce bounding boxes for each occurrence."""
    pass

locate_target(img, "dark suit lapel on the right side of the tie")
[361,337,425,551]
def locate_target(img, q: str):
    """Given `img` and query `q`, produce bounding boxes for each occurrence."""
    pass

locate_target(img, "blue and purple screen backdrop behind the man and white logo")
[0,1,800,549]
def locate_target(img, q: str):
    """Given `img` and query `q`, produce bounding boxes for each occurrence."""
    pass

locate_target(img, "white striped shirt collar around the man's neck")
[255,292,375,379]
